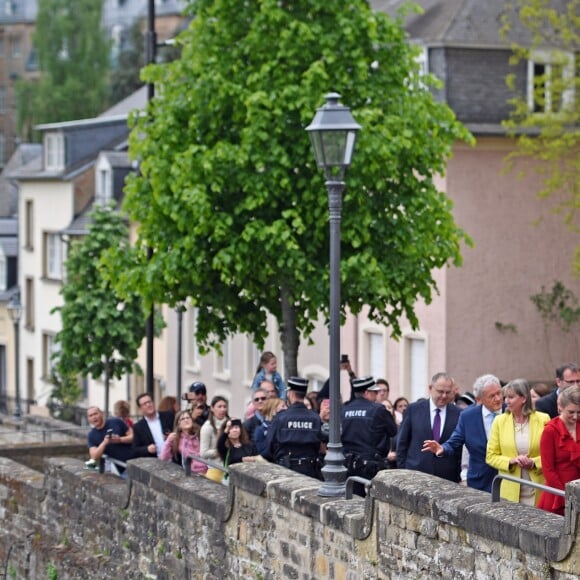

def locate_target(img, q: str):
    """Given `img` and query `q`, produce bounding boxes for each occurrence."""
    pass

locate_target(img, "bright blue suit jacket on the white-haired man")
[443,405,497,492]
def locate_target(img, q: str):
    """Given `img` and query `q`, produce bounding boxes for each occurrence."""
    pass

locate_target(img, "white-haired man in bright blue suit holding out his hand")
[423,375,503,492]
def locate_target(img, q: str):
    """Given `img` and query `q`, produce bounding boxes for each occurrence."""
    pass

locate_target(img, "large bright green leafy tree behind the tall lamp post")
[111,0,470,373]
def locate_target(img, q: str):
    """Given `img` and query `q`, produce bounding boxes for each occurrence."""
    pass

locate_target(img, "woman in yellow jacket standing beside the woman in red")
[485,379,550,505]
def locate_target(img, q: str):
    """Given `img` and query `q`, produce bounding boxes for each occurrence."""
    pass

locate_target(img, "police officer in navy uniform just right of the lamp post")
[342,377,397,495]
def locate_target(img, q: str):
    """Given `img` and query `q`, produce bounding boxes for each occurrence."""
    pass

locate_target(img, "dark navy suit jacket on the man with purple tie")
[397,399,461,482]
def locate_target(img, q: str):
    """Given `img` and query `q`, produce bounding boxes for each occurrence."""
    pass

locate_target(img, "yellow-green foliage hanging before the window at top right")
[503,0,580,250]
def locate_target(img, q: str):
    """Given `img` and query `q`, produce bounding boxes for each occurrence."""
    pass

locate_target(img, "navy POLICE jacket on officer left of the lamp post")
[263,403,321,462]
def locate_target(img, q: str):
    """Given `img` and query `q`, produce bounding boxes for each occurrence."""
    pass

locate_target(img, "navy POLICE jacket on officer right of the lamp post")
[342,398,397,459]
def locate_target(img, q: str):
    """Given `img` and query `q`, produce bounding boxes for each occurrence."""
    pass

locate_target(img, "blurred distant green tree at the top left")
[17,0,109,138]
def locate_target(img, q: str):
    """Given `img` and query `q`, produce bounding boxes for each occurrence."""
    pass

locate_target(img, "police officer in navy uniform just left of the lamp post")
[263,377,321,479]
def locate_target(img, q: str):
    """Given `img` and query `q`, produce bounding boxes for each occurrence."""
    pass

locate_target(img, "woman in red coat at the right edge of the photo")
[538,385,580,516]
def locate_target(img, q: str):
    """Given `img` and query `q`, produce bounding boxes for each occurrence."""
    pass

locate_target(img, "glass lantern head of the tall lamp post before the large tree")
[306,93,361,180]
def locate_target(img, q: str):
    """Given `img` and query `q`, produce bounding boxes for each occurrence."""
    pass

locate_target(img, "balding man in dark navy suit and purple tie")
[397,373,461,482]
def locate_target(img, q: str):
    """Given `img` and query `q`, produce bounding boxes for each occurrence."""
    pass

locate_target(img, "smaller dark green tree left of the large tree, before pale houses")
[54,204,146,410]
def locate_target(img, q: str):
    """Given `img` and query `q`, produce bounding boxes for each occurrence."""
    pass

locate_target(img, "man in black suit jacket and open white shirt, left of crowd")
[133,393,174,457]
